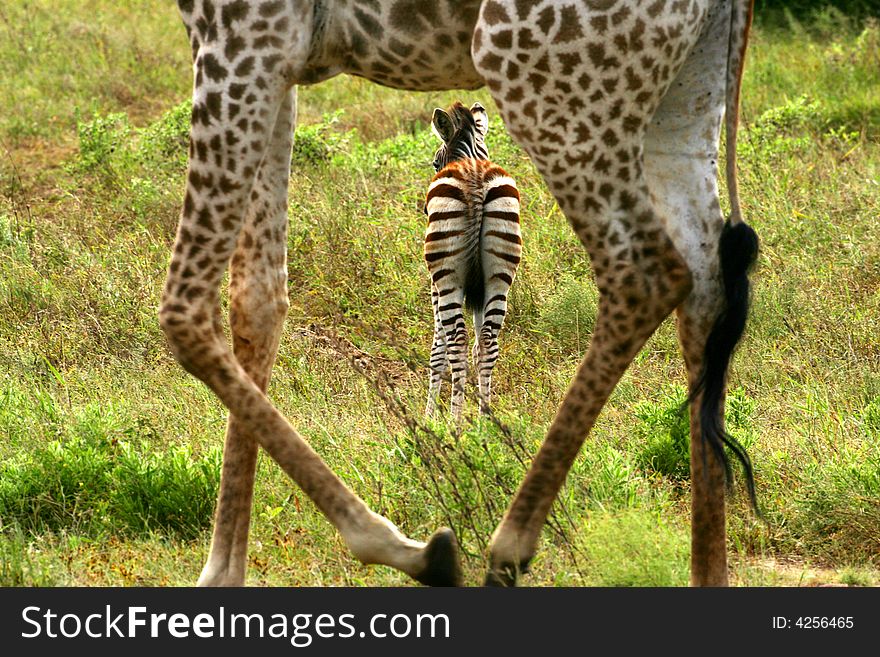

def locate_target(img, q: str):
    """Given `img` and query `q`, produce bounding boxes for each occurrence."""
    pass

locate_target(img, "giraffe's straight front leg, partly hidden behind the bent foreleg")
[199,87,296,586]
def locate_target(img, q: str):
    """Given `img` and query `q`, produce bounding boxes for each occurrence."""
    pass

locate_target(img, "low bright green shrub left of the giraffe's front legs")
[0,421,220,539]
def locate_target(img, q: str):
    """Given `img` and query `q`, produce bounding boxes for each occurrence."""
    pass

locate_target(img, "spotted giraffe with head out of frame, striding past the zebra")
[159,0,756,585]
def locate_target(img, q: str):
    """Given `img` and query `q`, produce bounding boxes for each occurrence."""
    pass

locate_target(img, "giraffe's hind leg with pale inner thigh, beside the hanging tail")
[645,4,748,586]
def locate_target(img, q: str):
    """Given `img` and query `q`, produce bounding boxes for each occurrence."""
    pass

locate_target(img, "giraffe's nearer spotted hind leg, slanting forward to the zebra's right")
[473,0,727,585]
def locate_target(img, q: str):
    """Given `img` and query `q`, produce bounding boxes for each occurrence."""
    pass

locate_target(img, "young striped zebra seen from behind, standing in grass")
[425,102,522,423]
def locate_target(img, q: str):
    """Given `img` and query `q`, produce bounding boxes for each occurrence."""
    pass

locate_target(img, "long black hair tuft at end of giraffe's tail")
[691,220,761,517]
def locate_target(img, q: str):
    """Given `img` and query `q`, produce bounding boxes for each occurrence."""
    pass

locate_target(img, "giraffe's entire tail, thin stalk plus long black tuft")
[691,0,762,517]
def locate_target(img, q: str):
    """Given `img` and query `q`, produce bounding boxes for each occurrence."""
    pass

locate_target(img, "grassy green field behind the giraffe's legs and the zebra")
[0,0,880,586]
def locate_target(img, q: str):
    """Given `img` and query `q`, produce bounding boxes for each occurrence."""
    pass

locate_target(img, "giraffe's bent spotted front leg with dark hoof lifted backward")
[159,36,461,584]
